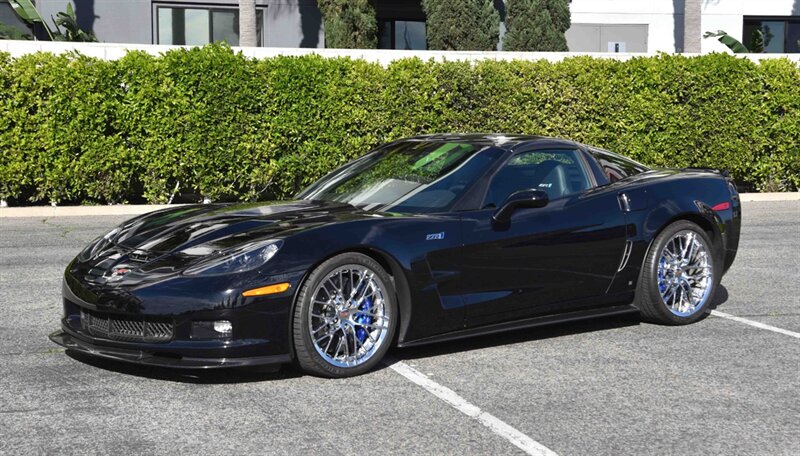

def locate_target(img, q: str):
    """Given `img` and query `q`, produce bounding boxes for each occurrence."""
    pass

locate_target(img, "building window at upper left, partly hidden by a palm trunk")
[156,6,264,46]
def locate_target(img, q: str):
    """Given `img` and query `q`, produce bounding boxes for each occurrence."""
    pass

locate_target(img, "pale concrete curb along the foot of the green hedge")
[0,192,800,218]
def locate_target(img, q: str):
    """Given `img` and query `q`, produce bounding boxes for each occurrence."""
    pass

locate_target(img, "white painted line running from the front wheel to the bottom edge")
[385,361,558,456]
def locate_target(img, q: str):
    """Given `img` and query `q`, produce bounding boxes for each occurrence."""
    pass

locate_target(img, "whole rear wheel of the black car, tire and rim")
[634,220,722,325]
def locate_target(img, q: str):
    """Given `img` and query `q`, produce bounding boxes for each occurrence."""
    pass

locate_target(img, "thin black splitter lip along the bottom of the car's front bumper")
[50,330,291,369]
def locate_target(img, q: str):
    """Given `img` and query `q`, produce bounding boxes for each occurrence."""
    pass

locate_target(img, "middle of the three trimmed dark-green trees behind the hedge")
[422,0,500,51]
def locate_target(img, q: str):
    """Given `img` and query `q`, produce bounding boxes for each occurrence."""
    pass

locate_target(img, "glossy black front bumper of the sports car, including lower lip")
[50,269,300,368]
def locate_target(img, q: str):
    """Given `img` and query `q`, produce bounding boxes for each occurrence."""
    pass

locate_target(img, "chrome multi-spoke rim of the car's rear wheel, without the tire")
[658,230,714,317]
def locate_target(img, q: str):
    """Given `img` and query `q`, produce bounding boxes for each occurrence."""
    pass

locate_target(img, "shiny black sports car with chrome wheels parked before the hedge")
[50,134,741,377]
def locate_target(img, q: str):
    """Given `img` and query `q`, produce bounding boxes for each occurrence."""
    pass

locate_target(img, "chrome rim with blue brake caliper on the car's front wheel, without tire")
[308,264,393,367]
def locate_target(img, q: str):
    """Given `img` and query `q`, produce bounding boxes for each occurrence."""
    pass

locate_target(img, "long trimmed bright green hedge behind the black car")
[0,45,800,204]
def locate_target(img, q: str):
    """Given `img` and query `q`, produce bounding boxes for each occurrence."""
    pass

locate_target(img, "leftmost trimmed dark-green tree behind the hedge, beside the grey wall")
[317,0,378,49]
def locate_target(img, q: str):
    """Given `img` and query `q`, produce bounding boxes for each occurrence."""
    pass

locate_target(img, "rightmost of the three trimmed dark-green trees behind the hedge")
[503,0,572,52]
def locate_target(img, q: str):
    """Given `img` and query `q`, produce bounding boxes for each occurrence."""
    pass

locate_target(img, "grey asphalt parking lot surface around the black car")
[0,202,800,455]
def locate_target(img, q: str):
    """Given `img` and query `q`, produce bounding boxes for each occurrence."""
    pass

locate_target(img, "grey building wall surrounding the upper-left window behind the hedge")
[32,0,324,47]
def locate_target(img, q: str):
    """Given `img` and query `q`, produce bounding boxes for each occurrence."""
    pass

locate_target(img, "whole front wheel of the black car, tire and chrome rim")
[292,253,399,378]
